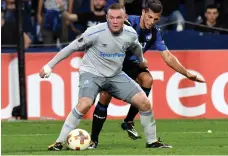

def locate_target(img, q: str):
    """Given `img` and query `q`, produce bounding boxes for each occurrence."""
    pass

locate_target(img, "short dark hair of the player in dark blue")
[144,0,163,13]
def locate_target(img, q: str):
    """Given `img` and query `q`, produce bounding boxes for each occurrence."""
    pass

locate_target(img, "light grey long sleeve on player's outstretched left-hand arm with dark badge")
[48,27,97,68]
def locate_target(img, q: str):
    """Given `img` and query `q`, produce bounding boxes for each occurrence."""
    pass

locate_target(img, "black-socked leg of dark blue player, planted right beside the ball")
[88,91,112,149]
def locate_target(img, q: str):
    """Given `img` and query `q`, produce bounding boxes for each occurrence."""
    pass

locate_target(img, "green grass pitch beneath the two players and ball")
[1,120,228,155]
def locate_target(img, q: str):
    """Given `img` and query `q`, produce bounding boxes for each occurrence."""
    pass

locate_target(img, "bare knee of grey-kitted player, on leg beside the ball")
[76,97,93,114]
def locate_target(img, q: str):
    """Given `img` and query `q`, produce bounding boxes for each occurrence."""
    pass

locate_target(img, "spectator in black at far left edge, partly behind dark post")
[1,8,31,49]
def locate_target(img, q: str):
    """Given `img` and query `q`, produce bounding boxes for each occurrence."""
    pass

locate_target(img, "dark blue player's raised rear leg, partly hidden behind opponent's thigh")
[121,69,153,140]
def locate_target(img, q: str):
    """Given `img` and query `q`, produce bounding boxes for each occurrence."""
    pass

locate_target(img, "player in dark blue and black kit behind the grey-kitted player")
[89,0,204,149]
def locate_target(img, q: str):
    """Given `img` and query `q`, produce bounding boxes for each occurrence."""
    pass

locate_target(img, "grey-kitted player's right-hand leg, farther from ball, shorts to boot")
[107,73,171,148]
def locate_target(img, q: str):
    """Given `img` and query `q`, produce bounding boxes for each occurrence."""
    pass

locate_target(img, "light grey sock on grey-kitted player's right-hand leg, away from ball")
[139,111,157,144]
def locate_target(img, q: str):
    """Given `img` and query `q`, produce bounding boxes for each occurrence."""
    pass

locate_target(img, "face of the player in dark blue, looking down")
[142,9,161,29]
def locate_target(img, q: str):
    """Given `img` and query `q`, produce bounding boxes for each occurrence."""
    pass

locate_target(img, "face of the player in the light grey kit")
[107,9,126,33]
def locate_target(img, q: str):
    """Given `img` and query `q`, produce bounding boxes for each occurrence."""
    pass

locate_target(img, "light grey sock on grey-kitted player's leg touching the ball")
[56,108,83,142]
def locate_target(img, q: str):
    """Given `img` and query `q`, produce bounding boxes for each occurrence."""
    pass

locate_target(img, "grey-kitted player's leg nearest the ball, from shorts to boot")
[48,73,101,151]
